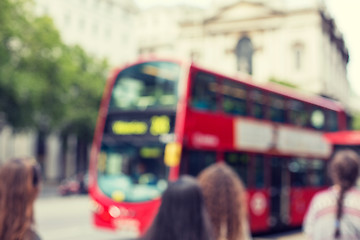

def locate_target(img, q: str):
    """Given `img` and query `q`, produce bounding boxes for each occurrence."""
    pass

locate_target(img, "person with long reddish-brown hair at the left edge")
[0,158,41,240]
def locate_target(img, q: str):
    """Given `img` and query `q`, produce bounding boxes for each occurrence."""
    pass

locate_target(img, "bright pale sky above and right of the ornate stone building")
[136,0,360,96]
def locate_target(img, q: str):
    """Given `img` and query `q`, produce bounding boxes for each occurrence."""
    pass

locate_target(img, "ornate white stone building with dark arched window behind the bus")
[139,0,350,109]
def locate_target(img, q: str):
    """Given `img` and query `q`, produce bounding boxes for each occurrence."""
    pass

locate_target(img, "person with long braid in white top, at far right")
[303,150,360,240]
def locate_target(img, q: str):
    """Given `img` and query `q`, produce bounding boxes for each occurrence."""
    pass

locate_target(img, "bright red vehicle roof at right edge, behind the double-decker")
[325,131,360,145]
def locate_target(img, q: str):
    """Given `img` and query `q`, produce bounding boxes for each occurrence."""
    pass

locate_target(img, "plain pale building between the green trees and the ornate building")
[35,0,137,66]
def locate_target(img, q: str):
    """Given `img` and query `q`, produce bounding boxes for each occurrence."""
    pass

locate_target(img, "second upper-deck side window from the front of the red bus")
[222,80,247,116]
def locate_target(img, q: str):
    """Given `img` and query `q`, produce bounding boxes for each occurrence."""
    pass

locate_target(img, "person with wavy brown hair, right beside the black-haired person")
[198,163,251,240]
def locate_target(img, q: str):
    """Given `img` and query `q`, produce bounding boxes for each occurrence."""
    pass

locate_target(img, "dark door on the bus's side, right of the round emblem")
[269,157,289,229]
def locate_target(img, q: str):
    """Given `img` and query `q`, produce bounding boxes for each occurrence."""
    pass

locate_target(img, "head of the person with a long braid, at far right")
[329,149,360,190]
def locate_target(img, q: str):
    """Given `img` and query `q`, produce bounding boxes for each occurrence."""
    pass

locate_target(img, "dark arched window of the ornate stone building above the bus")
[236,37,254,74]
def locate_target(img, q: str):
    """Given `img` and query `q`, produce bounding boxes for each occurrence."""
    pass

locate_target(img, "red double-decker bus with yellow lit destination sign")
[89,60,347,234]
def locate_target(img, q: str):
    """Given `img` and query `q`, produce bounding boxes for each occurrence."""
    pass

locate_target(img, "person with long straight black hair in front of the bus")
[141,176,213,240]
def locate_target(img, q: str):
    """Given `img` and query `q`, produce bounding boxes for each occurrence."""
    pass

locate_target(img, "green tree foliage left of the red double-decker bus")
[0,0,108,141]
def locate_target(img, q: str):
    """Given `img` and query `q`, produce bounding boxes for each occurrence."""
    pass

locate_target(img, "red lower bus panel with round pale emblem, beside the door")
[247,189,270,232]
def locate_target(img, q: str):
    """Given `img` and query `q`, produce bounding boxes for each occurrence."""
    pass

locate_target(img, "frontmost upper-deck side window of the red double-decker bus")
[191,72,217,111]
